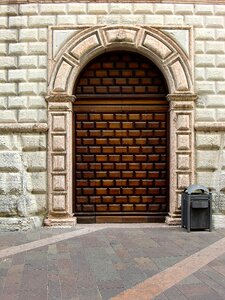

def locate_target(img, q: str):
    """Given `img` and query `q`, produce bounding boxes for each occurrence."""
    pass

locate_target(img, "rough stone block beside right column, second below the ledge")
[196,150,219,170]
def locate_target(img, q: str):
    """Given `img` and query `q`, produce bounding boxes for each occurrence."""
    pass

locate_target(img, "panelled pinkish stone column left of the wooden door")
[45,93,76,226]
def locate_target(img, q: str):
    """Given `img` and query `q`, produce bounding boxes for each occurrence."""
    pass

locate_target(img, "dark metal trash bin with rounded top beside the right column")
[181,184,212,232]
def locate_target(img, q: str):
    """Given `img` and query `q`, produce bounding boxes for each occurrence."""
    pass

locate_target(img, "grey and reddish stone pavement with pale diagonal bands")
[0,224,225,300]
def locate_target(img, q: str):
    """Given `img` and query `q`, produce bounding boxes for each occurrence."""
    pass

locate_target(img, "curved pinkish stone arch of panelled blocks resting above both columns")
[49,25,193,95]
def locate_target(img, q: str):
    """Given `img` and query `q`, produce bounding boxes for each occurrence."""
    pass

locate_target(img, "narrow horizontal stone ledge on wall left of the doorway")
[0,123,48,133]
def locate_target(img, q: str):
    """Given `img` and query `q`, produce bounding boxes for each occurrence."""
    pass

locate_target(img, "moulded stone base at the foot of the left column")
[44,215,77,227]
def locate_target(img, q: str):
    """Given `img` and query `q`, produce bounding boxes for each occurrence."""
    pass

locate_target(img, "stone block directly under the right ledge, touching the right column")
[196,133,221,149]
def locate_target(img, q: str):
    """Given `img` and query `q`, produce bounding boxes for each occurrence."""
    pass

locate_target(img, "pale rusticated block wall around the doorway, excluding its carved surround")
[0,2,225,227]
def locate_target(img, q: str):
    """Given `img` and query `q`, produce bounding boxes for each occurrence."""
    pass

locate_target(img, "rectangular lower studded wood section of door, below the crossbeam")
[75,106,168,221]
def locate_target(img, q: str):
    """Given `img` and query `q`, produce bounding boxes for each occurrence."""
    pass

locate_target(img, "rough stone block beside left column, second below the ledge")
[23,151,47,172]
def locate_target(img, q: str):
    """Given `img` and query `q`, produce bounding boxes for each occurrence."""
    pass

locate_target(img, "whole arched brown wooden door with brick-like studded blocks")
[73,51,169,223]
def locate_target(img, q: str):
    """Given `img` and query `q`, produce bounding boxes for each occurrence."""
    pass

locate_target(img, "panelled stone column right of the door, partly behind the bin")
[166,94,197,225]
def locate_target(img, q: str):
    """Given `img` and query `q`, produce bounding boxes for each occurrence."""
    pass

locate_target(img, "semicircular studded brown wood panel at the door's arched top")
[75,51,167,98]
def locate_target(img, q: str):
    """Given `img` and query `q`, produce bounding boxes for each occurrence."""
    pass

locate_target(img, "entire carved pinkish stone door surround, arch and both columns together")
[46,25,196,224]
